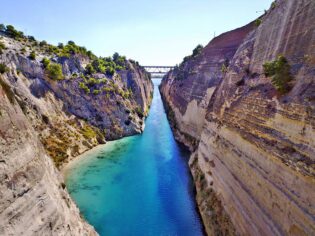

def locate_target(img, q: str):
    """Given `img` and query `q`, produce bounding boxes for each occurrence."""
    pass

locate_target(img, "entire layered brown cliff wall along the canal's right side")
[161,0,315,235]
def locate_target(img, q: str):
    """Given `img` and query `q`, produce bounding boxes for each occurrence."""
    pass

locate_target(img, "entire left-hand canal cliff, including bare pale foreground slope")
[0,30,153,232]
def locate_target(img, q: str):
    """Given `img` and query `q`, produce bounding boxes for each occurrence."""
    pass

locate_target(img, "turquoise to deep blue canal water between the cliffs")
[65,80,203,236]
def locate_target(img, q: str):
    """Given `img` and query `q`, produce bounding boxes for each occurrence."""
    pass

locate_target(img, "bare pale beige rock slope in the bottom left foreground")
[0,81,96,235]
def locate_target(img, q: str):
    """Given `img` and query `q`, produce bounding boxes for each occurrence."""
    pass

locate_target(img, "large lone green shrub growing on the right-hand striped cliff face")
[263,55,293,94]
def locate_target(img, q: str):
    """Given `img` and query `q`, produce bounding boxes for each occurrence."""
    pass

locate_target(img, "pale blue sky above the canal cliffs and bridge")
[0,0,272,66]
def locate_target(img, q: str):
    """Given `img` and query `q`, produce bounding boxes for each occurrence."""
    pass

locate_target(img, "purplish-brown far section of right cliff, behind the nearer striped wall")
[160,23,254,150]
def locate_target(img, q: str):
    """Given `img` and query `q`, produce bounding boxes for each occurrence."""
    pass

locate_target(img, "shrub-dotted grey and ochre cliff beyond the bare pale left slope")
[0,34,153,166]
